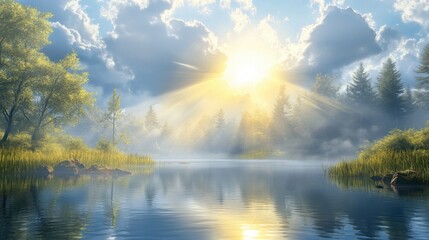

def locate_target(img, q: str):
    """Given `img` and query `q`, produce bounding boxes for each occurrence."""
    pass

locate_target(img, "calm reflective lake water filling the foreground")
[0,160,429,239]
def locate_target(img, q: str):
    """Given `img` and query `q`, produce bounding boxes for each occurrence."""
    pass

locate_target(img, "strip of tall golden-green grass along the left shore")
[0,147,153,176]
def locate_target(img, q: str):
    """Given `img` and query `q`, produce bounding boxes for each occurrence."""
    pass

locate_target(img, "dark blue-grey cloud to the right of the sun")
[300,6,381,74]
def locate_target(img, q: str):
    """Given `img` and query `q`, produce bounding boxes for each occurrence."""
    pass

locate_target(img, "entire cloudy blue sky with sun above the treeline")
[19,0,429,107]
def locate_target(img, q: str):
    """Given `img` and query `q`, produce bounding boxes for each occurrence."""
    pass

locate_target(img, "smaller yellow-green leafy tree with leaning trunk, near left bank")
[31,53,93,141]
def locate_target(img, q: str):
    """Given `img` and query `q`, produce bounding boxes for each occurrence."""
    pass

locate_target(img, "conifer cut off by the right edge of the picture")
[416,44,429,108]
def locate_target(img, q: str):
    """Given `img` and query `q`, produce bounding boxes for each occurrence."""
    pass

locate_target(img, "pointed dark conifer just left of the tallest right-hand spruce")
[347,63,375,105]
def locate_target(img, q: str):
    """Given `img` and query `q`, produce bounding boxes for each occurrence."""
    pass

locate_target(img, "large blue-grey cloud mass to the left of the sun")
[105,1,225,95]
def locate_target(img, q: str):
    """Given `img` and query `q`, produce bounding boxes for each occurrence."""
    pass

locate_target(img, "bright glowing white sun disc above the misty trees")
[223,51,272,90]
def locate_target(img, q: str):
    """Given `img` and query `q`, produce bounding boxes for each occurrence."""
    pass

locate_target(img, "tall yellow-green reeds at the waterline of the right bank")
[328,150,429,183]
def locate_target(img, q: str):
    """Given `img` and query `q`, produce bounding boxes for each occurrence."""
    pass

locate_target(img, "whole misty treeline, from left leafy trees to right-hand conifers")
[0,1,429,158]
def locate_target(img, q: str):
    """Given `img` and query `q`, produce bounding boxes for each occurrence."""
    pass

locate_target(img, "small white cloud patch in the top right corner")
[393,0,429,28]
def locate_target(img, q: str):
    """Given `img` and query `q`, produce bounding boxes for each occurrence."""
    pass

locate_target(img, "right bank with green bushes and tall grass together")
[328,128,429,184]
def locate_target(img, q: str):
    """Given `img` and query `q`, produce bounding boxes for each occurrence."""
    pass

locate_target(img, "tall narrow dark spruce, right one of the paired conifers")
[377,58,404,120]
